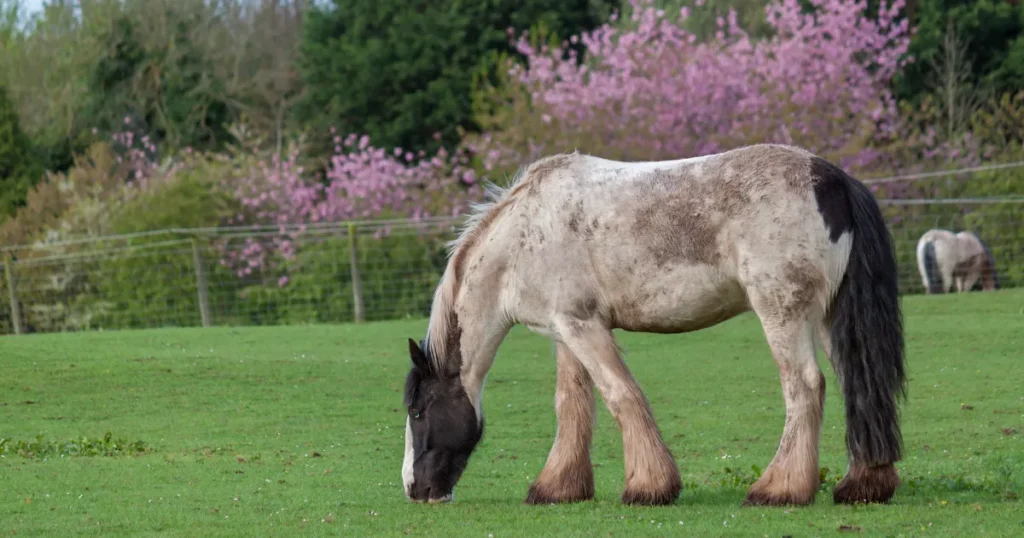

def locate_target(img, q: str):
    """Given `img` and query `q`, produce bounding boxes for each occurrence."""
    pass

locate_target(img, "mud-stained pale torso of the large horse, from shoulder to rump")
[508,144,845,332]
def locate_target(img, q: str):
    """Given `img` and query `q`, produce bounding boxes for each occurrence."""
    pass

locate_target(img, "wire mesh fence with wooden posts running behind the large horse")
[0,199,1024,334]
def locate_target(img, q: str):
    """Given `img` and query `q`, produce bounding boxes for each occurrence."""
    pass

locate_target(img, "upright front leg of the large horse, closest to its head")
[526,343,595,504]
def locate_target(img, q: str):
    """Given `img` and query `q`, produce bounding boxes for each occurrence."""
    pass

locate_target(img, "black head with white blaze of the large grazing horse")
[401,339,483,502]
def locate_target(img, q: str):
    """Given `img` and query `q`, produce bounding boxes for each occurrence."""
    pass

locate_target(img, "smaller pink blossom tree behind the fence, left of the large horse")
[221,129,479,286]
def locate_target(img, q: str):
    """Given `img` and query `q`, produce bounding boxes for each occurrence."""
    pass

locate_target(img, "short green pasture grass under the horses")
[0,291,1024,537]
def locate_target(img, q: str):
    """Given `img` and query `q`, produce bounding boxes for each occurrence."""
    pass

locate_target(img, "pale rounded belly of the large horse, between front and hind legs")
[613,265,750,333]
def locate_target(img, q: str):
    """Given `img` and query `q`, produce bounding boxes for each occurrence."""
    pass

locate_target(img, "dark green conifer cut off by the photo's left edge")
[0,85,43,223]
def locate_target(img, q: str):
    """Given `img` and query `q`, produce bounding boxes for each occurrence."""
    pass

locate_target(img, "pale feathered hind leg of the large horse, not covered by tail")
[743,290,825,505]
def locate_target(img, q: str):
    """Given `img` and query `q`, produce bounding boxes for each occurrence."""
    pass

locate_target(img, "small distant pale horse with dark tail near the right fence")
[918,230,999,293]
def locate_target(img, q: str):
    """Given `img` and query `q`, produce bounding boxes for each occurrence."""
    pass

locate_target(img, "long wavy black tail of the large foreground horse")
[812,159,906,473]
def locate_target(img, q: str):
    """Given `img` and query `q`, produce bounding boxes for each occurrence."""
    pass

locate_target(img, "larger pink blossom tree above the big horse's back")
[471,0,910,171]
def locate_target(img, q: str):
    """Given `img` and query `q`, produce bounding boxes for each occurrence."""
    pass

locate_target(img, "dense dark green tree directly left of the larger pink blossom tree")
[298,0,617,152]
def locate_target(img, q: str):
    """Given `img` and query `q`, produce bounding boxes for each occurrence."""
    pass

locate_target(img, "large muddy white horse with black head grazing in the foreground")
[402,144,905,505]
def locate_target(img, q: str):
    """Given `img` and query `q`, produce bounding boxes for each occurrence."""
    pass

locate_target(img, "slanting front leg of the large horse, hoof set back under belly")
[558,319,682,505]
